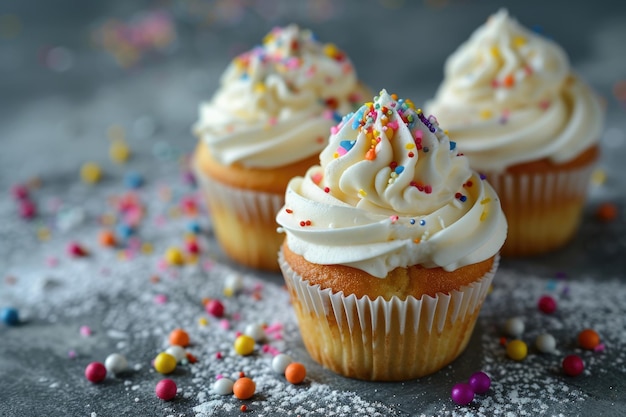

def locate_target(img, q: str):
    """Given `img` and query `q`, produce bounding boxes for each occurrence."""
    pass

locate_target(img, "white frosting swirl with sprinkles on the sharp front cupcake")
[276,90,507,278]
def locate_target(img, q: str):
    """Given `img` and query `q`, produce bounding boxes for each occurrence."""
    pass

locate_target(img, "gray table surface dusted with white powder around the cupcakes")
[0,0,626,416]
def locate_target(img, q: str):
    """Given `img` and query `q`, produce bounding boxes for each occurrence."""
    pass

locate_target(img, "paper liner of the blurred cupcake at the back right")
[486,165,593,256]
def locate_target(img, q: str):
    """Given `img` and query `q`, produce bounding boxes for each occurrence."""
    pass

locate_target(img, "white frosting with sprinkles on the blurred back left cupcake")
[193,25,364,168]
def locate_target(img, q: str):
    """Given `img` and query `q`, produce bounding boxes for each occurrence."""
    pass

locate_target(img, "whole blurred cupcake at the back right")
[425,10,604,256]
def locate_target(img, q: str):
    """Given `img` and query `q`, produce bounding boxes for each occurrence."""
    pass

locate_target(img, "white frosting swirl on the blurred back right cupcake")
[425,9,604,171]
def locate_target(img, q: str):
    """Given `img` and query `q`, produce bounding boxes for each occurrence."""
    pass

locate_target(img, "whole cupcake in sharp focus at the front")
[276,90,506,381]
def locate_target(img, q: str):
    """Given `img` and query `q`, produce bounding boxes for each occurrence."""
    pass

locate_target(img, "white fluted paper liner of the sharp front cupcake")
[279,250,499,381]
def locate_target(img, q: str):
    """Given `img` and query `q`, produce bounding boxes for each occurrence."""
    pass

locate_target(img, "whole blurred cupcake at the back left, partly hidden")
[192,25,369,271]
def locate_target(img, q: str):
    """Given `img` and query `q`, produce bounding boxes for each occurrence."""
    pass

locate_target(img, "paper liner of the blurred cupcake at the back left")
[196,170,284,271]
